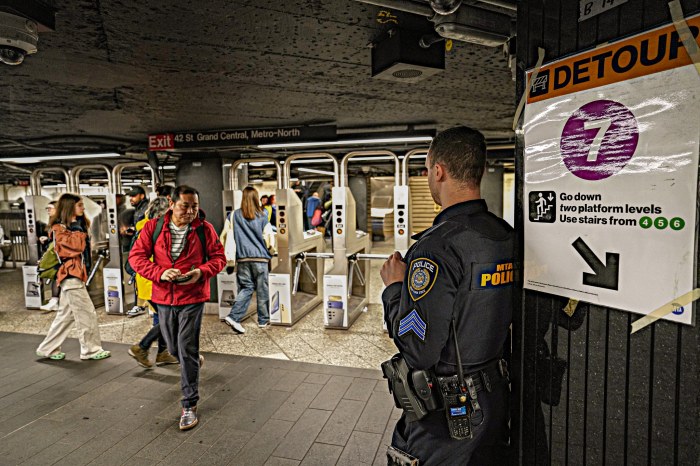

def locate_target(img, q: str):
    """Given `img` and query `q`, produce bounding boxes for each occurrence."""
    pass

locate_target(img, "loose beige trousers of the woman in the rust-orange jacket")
[36,278,102,359]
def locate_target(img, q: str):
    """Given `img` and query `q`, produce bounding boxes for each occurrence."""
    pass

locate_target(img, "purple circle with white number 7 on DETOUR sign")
[560,100,639,181]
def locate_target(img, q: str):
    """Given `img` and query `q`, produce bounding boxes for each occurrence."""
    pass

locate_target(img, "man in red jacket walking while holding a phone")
[129,185,226,430]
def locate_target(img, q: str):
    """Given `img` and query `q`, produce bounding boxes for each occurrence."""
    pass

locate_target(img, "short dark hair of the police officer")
[429,126,486,187]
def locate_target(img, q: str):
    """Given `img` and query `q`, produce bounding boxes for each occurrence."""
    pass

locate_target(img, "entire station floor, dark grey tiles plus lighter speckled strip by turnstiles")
[0,240,400,465]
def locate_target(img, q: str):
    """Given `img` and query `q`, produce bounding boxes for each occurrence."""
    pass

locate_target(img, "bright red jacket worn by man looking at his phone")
[129,211,226,306]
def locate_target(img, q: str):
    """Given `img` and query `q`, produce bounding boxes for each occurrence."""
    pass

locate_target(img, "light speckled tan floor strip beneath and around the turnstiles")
[0,245,396,369]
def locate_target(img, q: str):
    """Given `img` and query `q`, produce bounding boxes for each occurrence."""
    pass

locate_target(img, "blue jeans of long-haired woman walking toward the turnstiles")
[229,262,270,325]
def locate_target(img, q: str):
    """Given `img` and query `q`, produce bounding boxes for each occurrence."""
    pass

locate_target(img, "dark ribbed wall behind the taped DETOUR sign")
[512,0,700,465]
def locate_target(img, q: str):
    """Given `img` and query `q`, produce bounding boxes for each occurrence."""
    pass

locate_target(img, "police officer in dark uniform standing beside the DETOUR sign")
[381,127,514,466]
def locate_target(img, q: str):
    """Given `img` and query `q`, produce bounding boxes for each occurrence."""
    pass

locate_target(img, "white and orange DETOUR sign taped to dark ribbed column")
[523,16,700,324]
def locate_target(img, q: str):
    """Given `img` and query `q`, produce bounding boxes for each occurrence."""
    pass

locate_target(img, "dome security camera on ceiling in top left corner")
[0,12,39,65]
